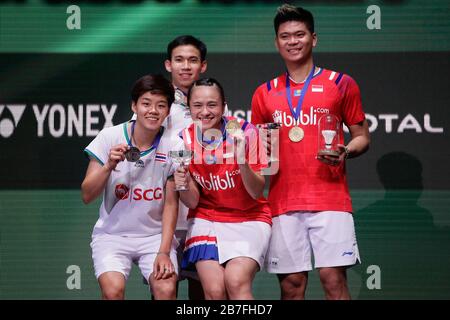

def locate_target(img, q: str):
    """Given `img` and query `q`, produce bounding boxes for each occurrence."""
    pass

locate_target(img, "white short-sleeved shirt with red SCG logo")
[84,120,183,237]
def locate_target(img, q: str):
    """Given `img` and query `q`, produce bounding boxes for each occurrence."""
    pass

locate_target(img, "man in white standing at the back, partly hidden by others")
[164,35,207,300]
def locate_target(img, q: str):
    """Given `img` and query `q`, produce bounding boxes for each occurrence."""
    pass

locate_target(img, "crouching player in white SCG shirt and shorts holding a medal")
[81,75,180,299]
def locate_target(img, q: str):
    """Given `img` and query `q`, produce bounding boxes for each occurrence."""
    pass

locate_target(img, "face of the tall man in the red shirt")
[275,21,317,63]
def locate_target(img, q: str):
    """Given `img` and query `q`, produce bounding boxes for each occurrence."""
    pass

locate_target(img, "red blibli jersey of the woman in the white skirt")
[182,117,272,225]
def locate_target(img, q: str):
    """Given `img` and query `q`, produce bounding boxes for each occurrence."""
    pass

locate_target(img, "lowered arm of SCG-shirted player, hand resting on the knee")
[153,177,178,280]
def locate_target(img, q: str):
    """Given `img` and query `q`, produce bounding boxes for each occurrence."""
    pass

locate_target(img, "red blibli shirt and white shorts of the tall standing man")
[252,68,365,273]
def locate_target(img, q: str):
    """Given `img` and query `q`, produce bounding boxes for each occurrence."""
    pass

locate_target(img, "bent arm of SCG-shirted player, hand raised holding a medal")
[81,144,129,204]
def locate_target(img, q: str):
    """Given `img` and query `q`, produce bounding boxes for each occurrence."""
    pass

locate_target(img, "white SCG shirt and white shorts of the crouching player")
[84,120,182,279]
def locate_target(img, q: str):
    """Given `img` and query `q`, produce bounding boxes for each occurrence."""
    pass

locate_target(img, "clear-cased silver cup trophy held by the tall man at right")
[318,114,340,157]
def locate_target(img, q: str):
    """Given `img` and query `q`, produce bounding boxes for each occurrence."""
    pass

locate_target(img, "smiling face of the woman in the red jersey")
[189,85,225,132]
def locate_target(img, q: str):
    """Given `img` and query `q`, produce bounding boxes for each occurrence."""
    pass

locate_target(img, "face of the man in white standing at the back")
[165,45,206,92]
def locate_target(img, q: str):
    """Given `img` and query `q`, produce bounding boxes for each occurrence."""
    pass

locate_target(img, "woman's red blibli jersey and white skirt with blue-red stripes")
[178,117,272,270]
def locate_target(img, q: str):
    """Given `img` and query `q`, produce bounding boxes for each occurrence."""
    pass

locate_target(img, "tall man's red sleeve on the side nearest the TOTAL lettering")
[338,75,366,126]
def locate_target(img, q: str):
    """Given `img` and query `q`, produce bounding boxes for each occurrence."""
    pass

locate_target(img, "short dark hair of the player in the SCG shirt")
[131,74,175,108]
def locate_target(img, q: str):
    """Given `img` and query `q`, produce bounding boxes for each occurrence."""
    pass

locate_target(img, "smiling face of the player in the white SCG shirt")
[131,91,169,131]
